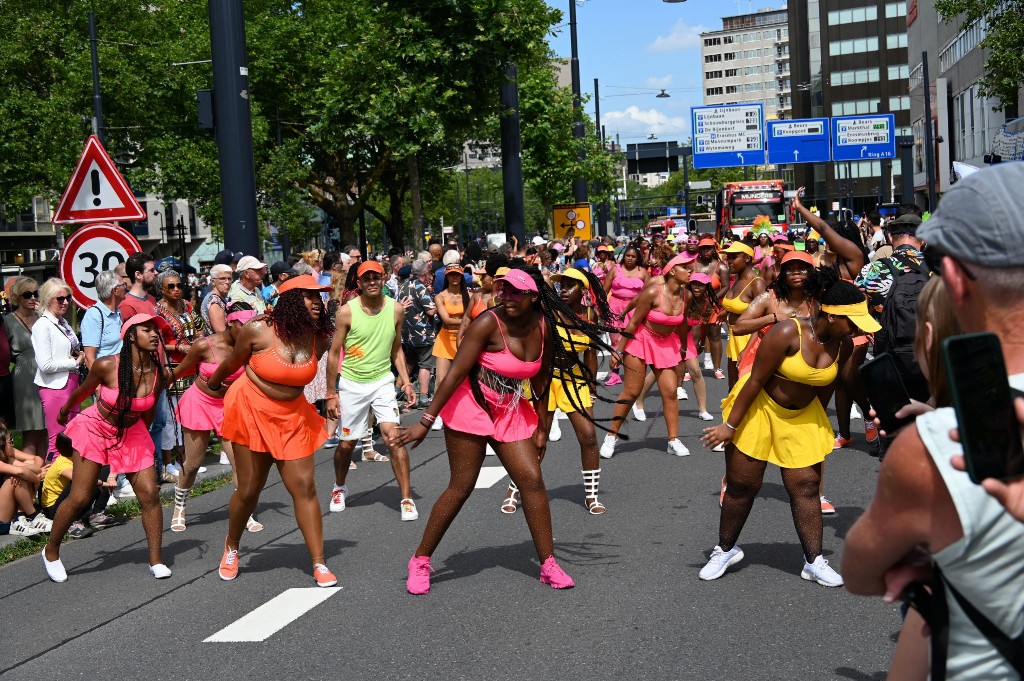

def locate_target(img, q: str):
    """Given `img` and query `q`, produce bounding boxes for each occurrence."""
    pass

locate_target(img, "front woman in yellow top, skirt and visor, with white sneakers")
[700,265,879,587]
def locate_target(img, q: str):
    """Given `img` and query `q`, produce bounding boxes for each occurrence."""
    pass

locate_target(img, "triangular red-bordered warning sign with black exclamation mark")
[53,135,145,224]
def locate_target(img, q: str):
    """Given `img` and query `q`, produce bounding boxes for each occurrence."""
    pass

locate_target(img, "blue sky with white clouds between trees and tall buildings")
[546,0,785,144]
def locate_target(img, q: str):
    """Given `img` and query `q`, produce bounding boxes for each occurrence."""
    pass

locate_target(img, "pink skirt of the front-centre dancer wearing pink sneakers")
[438,378,537,442]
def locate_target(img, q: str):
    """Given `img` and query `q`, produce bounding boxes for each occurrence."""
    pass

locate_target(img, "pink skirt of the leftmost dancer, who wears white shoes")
[65,405,154,473]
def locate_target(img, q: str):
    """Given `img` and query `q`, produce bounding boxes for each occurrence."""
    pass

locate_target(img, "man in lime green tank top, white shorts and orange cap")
[327,260,419,520]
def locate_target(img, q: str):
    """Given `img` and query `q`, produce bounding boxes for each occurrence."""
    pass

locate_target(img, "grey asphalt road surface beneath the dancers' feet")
[0,366,899,681]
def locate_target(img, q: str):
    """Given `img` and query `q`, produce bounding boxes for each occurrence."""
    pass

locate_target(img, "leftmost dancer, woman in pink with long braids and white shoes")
[42,313,171,582]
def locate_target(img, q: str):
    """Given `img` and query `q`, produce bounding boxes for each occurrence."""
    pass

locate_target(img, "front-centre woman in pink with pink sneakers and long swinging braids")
[400,268,609,594]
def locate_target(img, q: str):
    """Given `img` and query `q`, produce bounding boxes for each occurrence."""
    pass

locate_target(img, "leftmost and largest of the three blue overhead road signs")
[690,104,765,168]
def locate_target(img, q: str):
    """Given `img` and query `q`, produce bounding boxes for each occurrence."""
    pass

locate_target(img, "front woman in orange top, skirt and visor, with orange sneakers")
[206,274,338,587]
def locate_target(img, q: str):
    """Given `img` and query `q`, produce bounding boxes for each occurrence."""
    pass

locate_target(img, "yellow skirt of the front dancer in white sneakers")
[722,374,836,468]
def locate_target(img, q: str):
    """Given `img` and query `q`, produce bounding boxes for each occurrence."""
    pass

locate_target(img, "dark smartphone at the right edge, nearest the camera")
[942,334,1024,483]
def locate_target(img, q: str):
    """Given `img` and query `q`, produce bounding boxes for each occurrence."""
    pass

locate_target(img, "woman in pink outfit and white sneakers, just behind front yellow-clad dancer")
[600,254,693,459]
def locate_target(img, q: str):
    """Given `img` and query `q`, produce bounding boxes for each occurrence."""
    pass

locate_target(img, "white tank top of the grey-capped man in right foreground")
[916,374,1024,681]
